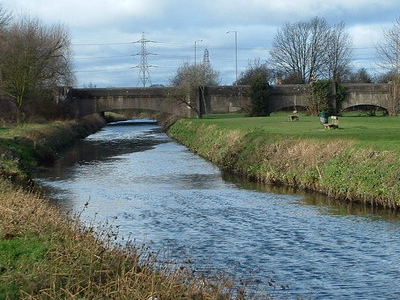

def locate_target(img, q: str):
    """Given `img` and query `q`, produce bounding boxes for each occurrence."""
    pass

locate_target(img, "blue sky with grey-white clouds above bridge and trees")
[0,0,400,88]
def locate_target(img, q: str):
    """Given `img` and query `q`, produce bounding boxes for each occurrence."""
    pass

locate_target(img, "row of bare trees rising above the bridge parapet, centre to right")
[170,17,400,86]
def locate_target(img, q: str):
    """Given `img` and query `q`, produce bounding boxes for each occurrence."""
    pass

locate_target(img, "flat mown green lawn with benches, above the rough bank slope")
[200,113,400,153]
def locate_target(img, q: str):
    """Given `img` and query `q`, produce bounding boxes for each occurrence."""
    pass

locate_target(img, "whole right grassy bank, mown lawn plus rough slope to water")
[169,114,400,209]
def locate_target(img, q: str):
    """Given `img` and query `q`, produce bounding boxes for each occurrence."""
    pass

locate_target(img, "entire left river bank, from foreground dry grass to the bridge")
[0,118,239,300]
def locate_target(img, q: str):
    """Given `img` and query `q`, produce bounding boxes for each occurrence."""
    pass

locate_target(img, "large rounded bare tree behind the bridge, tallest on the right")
[270,17,349,83]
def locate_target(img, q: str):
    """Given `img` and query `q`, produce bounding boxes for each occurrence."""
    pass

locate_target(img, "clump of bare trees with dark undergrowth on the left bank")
[0,6,75,122]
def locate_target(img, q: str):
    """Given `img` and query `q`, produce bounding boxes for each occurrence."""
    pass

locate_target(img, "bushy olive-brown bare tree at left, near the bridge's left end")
[0,17,73,121]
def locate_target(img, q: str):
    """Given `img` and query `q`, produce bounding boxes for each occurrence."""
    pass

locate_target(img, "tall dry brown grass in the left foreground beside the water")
[0,180,245,300]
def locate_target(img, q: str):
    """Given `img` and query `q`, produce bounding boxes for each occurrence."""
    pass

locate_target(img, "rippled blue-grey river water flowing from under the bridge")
[36,121,400,300]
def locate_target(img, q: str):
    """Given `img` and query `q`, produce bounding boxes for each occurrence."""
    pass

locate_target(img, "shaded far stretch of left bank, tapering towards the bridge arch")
[0,115,105,181]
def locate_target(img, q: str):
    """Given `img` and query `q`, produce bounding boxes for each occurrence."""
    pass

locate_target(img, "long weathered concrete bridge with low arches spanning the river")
[67,84,399,118]
